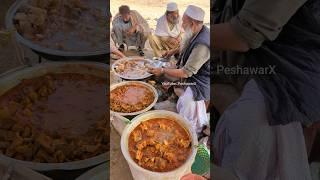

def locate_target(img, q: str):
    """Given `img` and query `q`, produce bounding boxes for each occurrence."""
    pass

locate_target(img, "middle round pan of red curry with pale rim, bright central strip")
[110,81,158,116]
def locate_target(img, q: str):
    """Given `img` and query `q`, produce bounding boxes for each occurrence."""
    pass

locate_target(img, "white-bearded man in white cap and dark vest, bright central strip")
[149,5,210,133]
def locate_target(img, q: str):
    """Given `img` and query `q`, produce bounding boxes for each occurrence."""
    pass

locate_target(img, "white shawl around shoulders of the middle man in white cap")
[154,15,182,38]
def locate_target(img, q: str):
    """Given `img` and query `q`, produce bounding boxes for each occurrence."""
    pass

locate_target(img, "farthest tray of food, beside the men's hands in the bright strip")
[112,58,152,80]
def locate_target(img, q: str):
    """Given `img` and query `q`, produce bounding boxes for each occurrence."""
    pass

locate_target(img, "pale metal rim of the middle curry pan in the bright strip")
[110,81,158,116]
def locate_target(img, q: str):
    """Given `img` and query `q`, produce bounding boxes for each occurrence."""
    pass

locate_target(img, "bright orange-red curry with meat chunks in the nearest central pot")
[128,118,191,172]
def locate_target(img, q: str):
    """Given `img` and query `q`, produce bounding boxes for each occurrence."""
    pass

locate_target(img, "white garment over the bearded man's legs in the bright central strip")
[177,87,209,133]
